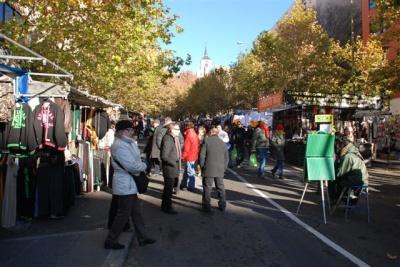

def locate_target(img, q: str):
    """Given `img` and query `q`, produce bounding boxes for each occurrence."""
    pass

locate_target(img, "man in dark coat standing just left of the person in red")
[161,123,181,214]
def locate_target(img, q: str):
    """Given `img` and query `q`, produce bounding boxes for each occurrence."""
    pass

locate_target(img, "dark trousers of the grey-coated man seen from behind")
[203,177,226,210]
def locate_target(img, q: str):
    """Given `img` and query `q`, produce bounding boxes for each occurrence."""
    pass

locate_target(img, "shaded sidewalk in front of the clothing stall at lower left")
[0,192,133,267]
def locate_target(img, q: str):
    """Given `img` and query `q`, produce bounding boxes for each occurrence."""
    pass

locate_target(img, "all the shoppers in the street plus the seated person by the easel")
[104,117,368,249]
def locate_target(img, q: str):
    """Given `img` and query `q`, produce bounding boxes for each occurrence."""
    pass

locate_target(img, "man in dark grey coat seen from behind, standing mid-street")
[199,128,229,212]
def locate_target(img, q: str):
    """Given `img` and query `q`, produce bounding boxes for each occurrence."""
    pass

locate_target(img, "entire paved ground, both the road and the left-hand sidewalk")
[0,160,400,266]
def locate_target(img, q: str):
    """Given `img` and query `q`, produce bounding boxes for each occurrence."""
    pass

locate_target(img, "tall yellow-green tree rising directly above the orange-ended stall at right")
[253,0,338,92]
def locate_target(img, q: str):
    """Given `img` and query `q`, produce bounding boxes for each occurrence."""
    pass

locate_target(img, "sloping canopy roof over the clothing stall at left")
[28,81,122,108]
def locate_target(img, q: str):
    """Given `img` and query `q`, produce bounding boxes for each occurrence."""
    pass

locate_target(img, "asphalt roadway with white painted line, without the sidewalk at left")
[126,161,400,266]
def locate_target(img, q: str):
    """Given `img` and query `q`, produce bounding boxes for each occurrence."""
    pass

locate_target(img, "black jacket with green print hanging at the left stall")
[7,103,36,154]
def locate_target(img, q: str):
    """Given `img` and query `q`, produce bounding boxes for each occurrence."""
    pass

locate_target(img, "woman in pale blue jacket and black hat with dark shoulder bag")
[104,120,155,249]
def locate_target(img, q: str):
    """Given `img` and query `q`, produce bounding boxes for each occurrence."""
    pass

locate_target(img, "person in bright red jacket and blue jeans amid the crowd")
[180,121,200,192]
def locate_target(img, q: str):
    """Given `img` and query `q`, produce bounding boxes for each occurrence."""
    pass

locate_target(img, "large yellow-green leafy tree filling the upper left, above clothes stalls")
[3,0,188,112]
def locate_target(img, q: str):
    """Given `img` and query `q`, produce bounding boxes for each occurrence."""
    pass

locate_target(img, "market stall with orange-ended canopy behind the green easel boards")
[258,92,386,166]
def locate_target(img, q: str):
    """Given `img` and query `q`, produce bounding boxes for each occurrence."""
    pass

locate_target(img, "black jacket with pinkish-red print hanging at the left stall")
[33,101,68,150]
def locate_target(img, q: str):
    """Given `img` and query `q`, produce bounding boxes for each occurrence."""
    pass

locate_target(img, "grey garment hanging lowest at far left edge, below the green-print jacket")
[1,157,18,228]
